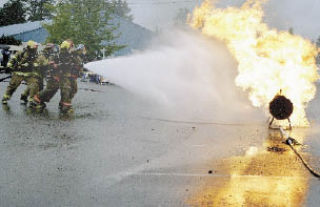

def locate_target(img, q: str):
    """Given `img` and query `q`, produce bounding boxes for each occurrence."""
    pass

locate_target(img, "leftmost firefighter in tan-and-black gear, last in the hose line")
[2,40,40,104]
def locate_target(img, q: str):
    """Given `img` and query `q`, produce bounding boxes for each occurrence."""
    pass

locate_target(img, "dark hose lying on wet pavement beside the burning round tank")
[280,127,320,178]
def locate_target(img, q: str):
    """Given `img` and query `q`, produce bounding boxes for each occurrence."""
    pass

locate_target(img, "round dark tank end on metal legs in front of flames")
[269,90,293,129]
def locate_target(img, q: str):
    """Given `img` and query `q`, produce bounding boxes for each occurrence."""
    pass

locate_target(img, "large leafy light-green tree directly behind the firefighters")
[44,0,123,60]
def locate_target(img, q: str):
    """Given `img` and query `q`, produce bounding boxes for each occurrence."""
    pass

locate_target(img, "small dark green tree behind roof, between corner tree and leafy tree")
[25,0,54,21]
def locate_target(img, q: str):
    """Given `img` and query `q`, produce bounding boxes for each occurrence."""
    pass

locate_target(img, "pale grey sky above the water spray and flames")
[0,0,320,40]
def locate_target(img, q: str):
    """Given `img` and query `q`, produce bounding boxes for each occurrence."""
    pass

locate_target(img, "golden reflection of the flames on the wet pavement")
[188,130,310,207]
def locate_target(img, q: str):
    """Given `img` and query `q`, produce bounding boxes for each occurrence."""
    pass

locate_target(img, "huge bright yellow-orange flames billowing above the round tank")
[190,0,319,126]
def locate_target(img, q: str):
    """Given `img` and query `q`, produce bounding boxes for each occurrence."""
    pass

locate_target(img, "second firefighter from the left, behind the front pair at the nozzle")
[33,43,61,108]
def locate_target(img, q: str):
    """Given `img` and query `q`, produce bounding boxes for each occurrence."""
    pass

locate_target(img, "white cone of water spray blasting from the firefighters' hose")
[85,30,258,122]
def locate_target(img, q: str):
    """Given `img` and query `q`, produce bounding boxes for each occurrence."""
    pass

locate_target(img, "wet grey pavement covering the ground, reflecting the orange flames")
[0,77,320,207]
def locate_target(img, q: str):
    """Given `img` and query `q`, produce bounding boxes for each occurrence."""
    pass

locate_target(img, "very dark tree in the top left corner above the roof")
[0,0,26,26]
